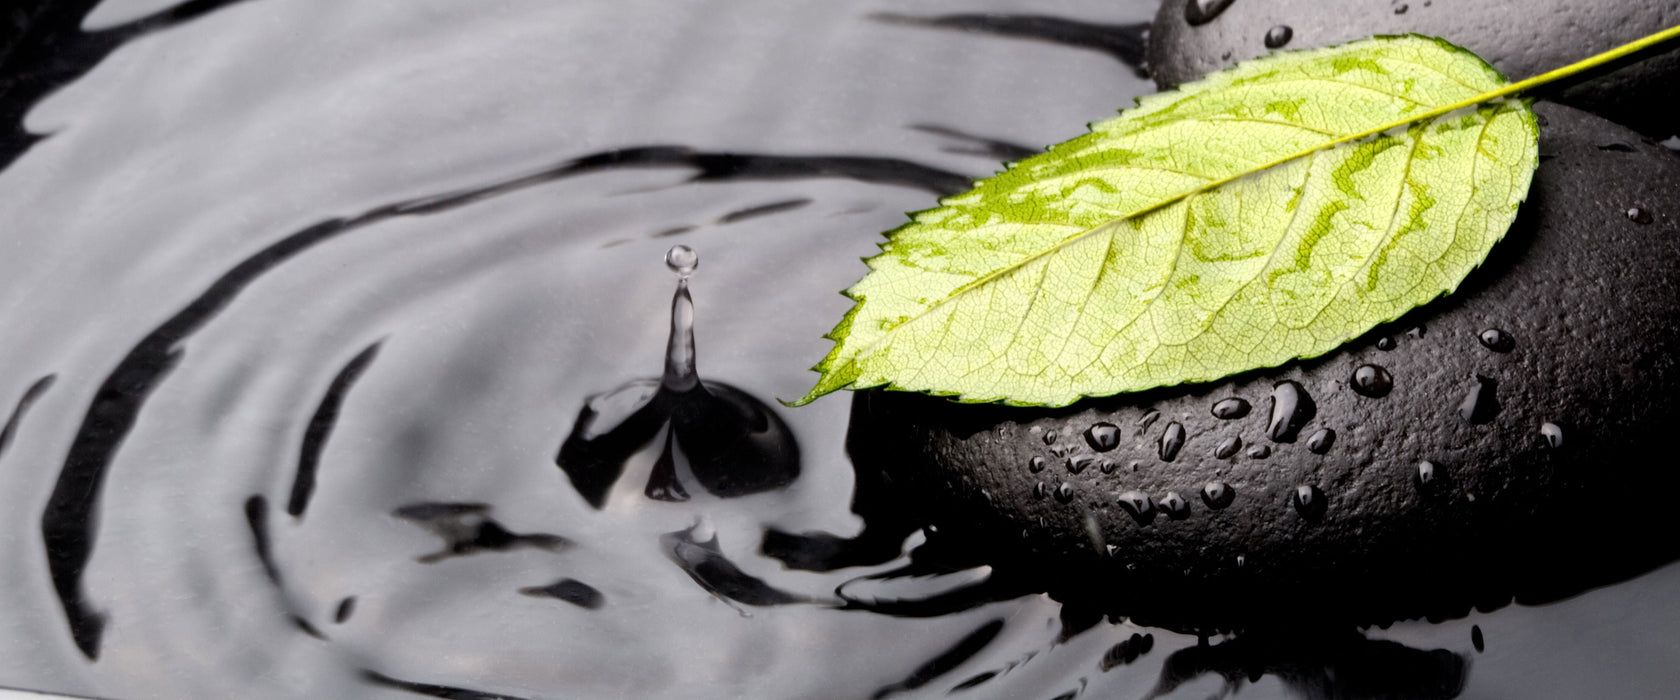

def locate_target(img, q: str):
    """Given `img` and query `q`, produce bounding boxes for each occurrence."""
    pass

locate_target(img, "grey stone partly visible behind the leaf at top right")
[1149,0,1680,138]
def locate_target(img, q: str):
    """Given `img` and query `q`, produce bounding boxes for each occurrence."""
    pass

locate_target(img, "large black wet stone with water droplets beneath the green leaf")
[848,104,1680,631]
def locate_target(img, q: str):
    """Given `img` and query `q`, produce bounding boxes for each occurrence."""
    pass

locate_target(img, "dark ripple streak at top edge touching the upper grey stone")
[874,12,1149,77]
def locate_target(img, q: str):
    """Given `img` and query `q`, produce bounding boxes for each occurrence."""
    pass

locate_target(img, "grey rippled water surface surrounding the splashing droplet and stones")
[0,0,1680,698]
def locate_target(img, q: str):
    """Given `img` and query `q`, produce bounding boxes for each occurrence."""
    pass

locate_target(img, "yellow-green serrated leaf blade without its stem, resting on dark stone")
[801,35,1539,406]
